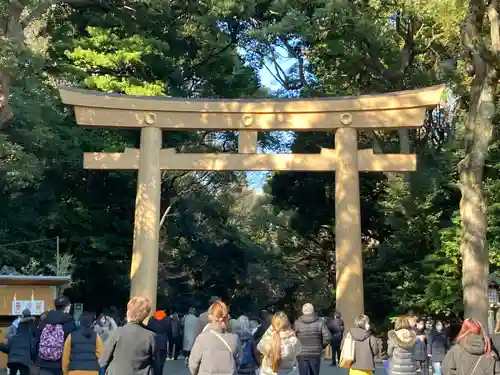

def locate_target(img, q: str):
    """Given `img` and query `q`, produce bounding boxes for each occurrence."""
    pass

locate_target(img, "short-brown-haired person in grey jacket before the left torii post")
[99,296,162,375]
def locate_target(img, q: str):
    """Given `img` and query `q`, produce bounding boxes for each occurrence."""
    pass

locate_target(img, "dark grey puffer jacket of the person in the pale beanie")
[295,314,331,358]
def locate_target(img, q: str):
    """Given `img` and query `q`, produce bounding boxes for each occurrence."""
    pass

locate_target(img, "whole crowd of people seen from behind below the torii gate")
[0,296,500,375]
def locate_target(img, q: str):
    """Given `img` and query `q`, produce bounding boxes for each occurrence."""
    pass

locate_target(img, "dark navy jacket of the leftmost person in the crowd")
[0,317,36,367]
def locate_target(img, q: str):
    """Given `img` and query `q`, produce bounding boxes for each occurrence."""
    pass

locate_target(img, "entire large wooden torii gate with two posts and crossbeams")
[59,85,444,326]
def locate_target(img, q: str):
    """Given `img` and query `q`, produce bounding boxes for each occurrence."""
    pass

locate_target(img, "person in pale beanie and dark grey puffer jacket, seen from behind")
[295,303,331,375]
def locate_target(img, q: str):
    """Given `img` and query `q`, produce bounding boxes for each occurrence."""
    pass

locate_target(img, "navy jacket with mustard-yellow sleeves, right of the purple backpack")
[62,327,103,374]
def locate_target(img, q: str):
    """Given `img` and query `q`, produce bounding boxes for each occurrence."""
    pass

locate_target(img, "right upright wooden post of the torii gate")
[335,128,364,327]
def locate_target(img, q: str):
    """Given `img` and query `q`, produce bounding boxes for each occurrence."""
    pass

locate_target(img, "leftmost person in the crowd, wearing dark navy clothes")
[0,309,36,375]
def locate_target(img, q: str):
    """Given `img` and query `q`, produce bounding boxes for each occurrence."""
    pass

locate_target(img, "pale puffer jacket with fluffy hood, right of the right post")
[387,329,417,375]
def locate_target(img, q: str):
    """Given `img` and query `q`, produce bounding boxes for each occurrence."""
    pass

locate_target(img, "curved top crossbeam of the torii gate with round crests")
[59,85,444,131]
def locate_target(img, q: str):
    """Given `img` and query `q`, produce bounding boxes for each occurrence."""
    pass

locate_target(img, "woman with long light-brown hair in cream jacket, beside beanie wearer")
[257,312,302,375]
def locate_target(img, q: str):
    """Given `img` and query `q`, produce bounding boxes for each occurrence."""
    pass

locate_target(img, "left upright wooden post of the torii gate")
[130,127,162,312]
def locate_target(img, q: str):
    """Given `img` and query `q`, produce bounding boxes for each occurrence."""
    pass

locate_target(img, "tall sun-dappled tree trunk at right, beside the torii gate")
[458,0,500,327]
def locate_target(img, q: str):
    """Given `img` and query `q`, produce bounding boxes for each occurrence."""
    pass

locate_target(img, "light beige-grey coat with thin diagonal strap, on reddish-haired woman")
[189,323,241,375]
